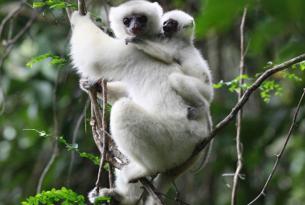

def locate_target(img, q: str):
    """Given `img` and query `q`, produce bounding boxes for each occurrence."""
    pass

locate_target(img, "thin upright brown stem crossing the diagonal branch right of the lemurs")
[231,7,247,205]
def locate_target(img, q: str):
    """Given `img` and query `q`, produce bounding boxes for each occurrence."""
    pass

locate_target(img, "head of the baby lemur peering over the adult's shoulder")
[161,10,195,41]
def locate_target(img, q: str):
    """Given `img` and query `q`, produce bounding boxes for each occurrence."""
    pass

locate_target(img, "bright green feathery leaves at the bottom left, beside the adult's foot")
[21,187,85,205]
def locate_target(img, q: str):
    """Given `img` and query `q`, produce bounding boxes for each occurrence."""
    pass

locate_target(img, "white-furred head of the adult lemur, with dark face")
[109,0,163,39]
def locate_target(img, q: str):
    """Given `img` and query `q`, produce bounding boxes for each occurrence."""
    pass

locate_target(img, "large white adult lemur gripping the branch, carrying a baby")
[71,1,208,204]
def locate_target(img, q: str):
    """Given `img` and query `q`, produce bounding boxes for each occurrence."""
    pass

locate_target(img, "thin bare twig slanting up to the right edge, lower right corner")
[248,88,305,205]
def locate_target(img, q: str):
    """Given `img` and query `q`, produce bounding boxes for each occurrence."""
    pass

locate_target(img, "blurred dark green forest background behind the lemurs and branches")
[0,0,305,205]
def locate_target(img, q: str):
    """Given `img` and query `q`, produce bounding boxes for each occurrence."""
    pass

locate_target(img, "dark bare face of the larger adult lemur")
[123,14,148,36]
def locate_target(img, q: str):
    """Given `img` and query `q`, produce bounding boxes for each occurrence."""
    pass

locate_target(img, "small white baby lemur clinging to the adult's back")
[126,10,214,118]
